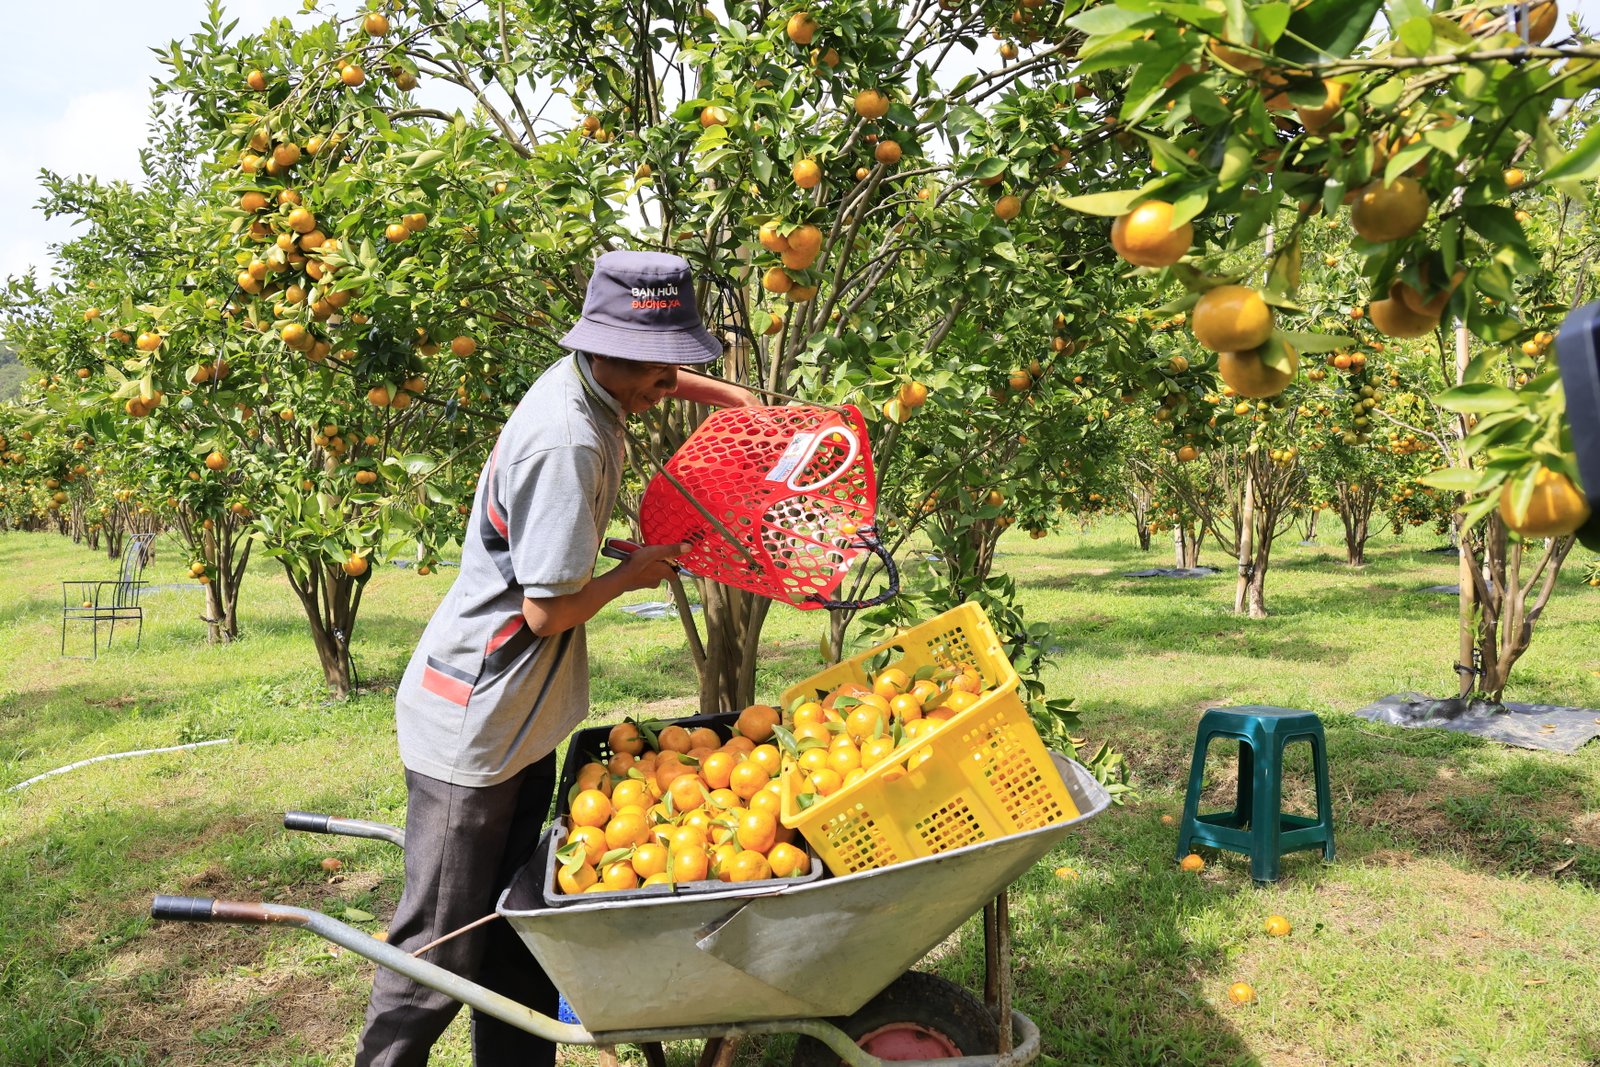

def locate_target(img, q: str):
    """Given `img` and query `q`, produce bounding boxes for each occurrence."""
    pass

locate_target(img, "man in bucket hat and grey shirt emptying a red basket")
[357,251,754,1067]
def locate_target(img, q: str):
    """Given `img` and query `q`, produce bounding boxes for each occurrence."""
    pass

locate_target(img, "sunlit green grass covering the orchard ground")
[0,523,1600,1067]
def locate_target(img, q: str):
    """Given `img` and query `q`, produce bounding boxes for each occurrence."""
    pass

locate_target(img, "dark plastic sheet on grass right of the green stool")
[1355,693,1600,755]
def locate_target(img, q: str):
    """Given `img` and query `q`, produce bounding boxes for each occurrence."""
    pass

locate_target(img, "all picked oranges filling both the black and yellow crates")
[557,665,984,894]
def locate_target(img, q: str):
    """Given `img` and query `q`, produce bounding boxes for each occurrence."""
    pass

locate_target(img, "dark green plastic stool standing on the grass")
[1178,705,1333,881]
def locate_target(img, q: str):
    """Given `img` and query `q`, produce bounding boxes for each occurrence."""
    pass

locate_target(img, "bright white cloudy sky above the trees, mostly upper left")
[9,0,1600,286]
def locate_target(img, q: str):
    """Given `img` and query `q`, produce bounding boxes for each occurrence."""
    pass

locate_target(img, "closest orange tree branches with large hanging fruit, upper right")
[1069,0,1600,696]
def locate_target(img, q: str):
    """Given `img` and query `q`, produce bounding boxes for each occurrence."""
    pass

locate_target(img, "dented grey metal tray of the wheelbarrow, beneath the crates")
[496,753,1110,1032]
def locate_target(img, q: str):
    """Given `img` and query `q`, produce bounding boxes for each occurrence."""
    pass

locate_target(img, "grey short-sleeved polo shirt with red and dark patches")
[395,355,624,785]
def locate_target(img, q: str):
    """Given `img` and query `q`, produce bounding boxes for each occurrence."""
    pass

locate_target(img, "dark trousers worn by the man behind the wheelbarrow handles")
[355,752,557,1067]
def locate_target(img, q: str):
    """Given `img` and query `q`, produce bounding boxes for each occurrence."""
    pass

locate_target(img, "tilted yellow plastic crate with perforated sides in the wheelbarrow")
[782,603,1078,875]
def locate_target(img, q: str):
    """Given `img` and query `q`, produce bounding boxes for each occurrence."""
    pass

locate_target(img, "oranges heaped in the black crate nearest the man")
[557,704,811,893]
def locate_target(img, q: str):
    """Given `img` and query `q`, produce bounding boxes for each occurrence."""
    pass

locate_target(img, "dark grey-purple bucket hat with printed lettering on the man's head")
[562,251,722,363]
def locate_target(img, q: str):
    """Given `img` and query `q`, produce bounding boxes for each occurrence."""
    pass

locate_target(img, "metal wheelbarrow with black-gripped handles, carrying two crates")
[150,753,1110,1067]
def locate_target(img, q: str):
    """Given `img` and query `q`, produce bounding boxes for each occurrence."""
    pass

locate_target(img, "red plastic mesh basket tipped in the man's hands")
[640,406,877,608]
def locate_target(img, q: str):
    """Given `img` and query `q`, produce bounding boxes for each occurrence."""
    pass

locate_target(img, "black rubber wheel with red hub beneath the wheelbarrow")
[792,971,1000,1067]
